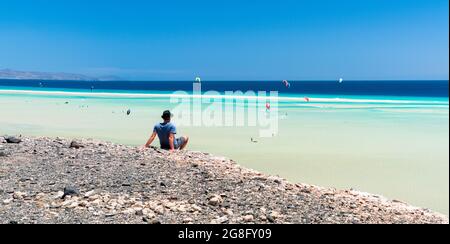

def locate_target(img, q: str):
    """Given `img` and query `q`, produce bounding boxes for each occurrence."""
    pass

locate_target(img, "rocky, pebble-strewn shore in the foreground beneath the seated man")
[0,137,448,224]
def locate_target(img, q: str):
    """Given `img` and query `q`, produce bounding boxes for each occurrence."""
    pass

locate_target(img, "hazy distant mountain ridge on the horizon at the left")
[0,69,121,81]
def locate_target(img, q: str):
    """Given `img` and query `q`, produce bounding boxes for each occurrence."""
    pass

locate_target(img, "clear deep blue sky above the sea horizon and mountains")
[0,0,449,80]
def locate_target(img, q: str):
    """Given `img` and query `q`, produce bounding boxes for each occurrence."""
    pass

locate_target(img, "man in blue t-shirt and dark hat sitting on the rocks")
[143,110,189,151]
